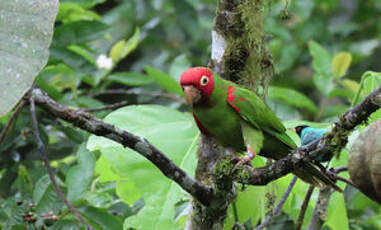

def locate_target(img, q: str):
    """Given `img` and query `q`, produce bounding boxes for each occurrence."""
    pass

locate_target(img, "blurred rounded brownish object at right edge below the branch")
[348,119,381,204]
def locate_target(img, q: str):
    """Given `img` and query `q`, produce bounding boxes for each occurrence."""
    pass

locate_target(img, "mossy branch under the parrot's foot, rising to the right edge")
[235,86,381,185]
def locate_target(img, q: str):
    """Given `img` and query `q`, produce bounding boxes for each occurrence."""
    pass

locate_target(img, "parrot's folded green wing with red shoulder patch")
[227,85,297,148]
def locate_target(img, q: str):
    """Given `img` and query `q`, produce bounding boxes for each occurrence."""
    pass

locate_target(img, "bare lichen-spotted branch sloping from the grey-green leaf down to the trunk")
[30,89,214,206]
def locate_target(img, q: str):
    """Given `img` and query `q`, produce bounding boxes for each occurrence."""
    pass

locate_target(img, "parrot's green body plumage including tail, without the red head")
[193,74,340,191]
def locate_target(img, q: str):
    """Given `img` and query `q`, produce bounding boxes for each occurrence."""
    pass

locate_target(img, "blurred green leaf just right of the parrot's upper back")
[268,86,318,113]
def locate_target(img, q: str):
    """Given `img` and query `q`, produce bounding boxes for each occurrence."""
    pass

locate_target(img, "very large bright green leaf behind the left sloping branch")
[87,105,198,229]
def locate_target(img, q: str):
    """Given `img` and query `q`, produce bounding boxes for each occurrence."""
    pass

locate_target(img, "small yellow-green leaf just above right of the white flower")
[109,28,140,63]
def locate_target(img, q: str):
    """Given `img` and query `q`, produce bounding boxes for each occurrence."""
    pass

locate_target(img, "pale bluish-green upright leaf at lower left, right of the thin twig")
[66,145,95,203]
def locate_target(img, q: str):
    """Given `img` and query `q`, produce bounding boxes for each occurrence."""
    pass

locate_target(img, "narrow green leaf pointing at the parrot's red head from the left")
[144,66,184,96]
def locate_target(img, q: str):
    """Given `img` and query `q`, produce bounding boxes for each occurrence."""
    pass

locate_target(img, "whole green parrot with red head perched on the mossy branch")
[180,67,341,191]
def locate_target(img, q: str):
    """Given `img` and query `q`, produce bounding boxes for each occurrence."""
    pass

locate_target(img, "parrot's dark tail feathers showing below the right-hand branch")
[294,163,343,193]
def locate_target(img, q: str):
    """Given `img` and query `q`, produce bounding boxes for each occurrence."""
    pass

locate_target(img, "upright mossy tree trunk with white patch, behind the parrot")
[186,0,273,230]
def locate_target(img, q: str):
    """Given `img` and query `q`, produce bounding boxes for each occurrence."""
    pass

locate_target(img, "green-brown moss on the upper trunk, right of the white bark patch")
[211,0,273,98]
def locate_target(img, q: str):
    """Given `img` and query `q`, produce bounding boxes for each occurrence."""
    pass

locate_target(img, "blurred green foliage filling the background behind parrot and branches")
[0,0,381,230]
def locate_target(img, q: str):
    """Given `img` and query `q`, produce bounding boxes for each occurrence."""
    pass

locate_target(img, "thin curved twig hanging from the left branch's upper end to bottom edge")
[29,96,93,230]
